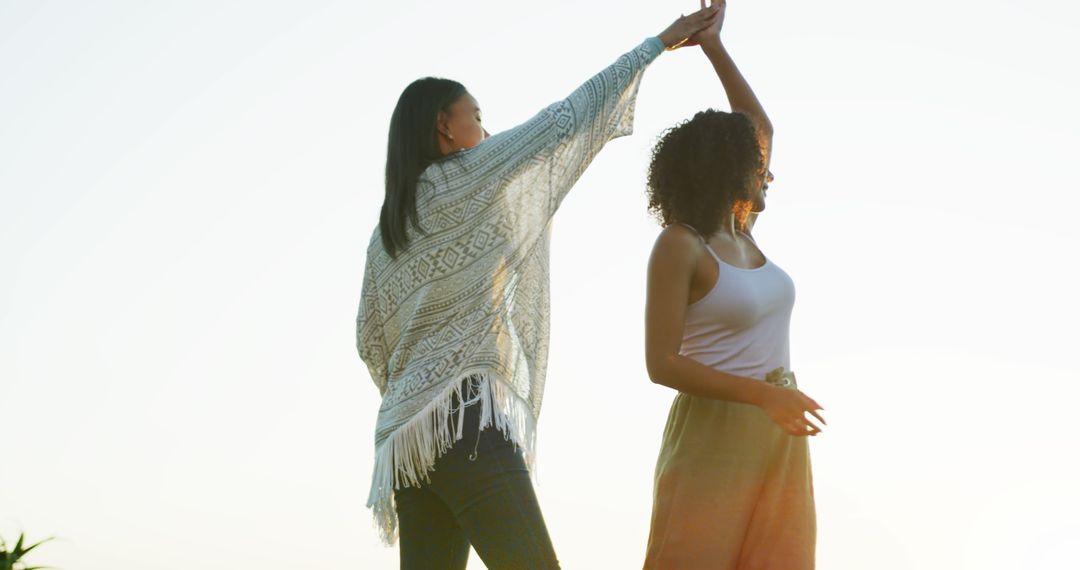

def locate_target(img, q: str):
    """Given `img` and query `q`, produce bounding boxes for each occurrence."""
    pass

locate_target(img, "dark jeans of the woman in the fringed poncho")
[394,377,558,570]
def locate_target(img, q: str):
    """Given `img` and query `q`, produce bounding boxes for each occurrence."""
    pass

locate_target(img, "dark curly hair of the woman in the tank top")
[646,109,765,236]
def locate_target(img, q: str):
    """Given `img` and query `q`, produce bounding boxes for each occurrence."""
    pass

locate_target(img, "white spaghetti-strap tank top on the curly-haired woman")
[679,228,795,380]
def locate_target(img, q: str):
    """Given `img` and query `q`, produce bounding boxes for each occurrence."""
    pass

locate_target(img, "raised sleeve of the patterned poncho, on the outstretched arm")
[451,38,663,224]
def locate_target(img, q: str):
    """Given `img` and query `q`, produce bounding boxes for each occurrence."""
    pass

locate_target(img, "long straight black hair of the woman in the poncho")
[379,78,465,257]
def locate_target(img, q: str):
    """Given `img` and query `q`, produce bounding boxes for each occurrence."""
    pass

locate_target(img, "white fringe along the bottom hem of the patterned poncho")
[367,372,536,545]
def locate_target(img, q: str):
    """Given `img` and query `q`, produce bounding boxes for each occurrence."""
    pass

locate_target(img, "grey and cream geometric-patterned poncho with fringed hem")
[356,38,663,543]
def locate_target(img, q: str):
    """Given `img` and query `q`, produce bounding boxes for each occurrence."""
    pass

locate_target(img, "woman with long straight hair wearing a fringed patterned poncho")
[356,8,718,570]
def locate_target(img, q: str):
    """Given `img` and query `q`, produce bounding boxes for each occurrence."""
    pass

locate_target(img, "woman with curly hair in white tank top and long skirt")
[645,0,824,570]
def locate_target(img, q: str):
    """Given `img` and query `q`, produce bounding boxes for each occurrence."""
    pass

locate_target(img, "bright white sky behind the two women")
[0,0,1080,570]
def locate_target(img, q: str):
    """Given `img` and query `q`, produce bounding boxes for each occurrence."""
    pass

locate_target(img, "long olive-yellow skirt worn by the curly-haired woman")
[645,394,816,570]
